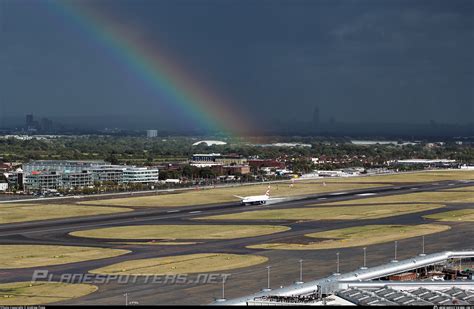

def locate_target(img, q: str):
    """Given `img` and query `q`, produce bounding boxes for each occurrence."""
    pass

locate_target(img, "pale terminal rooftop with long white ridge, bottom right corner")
[218,250,474,305]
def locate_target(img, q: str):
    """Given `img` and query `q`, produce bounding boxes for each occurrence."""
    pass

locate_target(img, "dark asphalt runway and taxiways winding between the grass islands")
[0,181,474,305]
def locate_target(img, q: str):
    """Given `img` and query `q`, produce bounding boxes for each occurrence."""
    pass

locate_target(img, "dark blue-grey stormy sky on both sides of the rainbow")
[0,0,474,130]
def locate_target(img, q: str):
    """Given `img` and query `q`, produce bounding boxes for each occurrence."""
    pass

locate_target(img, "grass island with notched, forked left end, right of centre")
[247,224,450,250]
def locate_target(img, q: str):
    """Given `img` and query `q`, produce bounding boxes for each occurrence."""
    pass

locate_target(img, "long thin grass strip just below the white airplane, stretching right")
[196,204,444,221]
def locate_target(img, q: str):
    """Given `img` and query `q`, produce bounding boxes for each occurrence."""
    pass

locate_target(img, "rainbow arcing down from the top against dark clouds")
[47,0,254,136]
